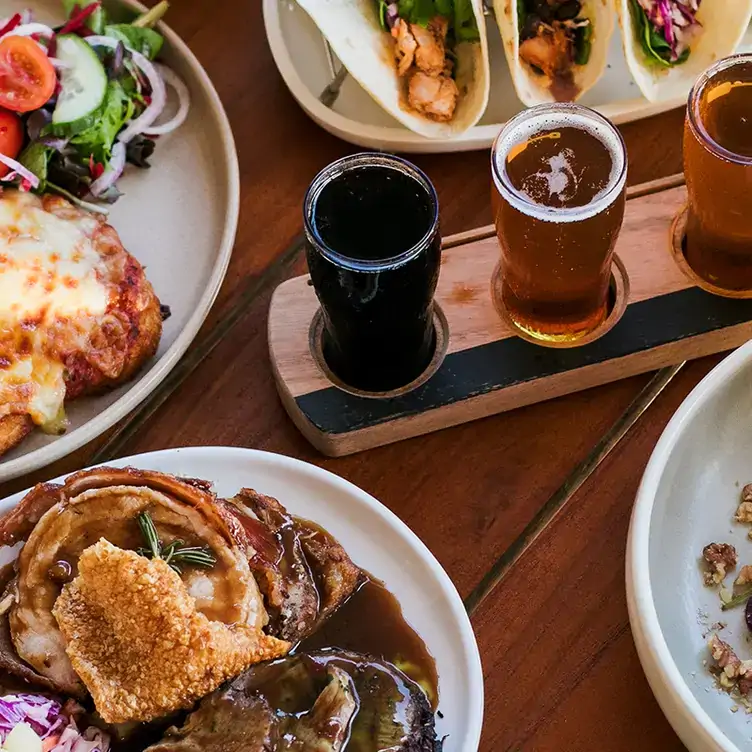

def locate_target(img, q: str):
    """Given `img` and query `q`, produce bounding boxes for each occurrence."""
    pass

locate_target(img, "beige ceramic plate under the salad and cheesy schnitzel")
[0,0,240,481]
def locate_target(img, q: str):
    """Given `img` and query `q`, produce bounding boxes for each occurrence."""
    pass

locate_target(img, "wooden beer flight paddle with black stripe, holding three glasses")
[269,175,752,456]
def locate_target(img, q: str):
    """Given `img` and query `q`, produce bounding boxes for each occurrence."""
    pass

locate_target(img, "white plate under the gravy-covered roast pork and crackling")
[0,447,483,752]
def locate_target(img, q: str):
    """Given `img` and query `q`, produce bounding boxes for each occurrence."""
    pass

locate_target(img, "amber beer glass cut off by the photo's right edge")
[684,54,752,292]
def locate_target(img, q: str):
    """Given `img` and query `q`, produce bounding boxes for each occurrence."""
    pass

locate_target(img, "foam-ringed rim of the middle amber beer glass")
[491,102,627,222]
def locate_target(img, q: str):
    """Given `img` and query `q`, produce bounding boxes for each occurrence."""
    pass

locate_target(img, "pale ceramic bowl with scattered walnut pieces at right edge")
[627,342,752,752]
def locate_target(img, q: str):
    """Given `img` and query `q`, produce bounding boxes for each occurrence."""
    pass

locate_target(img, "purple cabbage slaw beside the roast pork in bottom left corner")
[0,694,110,752]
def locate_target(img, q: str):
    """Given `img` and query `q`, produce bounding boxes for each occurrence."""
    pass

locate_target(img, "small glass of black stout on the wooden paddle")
[304,153,441,392]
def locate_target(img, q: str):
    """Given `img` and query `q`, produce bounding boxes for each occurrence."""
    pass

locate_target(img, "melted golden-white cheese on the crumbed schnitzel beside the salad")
[0,191,109,432]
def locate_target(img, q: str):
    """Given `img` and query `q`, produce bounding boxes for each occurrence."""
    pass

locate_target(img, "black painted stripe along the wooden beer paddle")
[296,287,752,434]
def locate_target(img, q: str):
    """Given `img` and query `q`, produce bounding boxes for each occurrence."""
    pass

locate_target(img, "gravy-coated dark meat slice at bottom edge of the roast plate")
[186,649,442,752]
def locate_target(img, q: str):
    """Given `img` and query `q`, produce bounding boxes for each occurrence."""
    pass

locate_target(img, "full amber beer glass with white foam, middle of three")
[491,103,627,343]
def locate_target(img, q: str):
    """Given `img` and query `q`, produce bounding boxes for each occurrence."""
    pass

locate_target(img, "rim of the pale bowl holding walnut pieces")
[626,341,752,752]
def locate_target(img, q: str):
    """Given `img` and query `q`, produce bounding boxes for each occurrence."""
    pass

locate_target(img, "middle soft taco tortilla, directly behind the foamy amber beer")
[494,0,615,107]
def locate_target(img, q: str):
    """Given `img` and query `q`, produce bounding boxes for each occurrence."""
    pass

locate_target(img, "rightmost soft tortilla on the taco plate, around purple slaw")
[617,0,752,104]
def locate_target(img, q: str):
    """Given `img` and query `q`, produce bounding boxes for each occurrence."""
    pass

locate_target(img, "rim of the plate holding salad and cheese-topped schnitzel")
[0,0,240,481]
